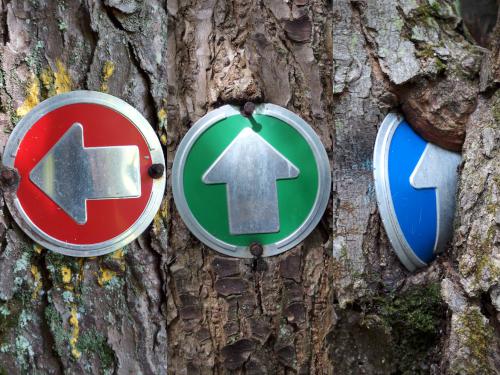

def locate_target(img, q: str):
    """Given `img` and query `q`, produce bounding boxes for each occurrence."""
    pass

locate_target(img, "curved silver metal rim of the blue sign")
[373,113,427,271]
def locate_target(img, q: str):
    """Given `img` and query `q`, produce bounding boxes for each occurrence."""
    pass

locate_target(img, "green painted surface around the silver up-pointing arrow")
[183,115,318,246]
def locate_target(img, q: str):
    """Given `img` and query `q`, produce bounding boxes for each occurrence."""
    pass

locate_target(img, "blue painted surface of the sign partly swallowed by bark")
[389,121,437,263]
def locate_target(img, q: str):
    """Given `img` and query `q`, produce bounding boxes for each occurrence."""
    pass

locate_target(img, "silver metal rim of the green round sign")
[172,103,331,258]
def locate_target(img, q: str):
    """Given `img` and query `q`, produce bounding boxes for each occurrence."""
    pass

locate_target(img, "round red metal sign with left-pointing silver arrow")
[3,91,165,257]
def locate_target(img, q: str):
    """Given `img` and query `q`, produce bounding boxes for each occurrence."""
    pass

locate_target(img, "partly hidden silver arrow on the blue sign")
[410,143,462,252]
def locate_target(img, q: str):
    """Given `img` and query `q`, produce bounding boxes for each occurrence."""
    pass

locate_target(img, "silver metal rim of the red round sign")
[2,90,166,257]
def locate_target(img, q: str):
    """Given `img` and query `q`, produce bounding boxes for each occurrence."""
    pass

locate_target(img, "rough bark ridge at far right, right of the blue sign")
[442,11,500,374]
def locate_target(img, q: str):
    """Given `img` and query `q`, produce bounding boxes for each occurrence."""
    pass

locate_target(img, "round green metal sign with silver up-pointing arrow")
[172,104,331,258]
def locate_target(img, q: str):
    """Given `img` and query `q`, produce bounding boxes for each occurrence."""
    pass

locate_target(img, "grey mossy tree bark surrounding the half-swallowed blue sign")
[332,1,500,374]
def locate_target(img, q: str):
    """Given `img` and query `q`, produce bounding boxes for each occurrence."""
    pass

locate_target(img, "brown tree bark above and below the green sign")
[167,0,333,374]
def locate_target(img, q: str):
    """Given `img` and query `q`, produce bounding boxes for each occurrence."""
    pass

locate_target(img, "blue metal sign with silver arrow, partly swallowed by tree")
[373,113,461,271]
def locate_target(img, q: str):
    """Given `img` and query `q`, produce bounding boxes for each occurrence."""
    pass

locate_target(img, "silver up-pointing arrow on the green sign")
[202,128,299,234]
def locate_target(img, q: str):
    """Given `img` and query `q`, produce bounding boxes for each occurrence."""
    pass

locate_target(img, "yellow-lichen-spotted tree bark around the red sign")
[0,0,167,374]
